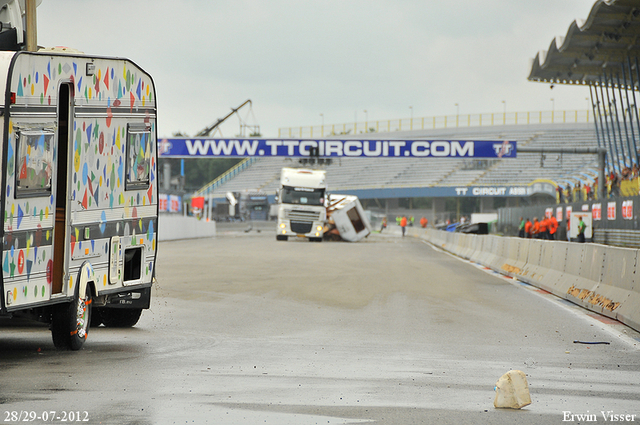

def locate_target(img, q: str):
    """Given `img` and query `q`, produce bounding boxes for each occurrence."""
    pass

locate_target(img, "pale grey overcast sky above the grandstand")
[38,0,595,137]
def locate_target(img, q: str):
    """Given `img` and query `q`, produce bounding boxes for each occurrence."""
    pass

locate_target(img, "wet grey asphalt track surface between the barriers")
[0,226,640,425]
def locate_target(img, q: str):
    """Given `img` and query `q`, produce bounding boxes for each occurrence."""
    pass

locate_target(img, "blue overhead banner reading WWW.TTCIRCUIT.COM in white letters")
[158,138,516,158]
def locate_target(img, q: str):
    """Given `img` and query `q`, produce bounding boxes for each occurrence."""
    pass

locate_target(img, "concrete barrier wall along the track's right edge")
[409,228,640,331]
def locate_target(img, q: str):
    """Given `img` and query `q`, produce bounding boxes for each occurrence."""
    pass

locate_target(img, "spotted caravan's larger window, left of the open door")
[16,130,54,197]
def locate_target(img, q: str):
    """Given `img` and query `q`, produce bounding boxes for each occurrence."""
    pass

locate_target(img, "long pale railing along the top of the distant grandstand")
[278,110,593,138]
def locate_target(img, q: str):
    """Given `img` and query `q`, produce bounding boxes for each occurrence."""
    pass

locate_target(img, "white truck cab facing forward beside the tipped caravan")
[276,168,327,242]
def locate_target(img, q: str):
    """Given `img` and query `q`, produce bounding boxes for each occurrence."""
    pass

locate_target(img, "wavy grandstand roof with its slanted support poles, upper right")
[529,0,640,175]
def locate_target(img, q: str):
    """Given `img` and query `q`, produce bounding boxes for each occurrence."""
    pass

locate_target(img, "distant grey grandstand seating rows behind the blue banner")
[199,123,598,199]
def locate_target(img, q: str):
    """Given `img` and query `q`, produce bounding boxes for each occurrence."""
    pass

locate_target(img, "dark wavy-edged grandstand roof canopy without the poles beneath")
[529,0,640,87]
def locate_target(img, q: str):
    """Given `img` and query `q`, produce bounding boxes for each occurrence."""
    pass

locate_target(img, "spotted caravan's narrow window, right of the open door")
[126,127,151,190]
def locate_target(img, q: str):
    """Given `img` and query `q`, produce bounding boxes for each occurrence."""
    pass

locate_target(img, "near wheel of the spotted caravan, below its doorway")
[51,285,91,350]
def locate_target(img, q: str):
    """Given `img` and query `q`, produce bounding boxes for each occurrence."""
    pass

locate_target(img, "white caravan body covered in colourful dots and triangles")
[0,52,158,312]
